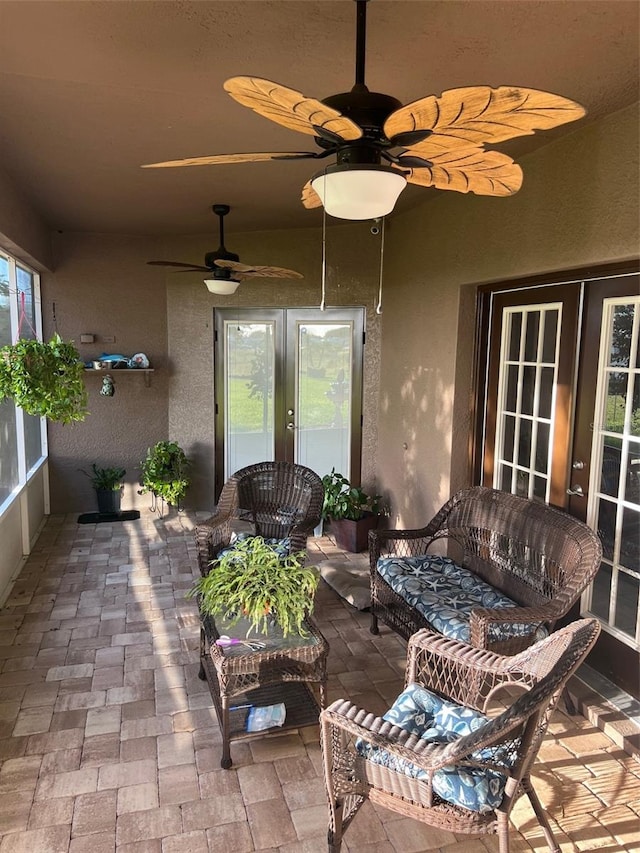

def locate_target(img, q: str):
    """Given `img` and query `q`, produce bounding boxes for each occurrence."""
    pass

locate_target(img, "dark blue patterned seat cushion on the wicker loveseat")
[377,555,547,643]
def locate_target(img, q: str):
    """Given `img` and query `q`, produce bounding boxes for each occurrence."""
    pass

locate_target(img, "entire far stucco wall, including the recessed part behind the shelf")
[43,223,380,512]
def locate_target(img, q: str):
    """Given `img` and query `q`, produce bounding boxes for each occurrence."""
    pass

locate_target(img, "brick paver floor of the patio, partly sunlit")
[0,512,640,853]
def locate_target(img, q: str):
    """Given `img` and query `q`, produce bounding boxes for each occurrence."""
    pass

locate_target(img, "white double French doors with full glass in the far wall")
[215,308,364,492]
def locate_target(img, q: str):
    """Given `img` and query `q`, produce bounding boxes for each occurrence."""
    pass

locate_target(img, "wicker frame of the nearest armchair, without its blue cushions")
[320,619,600,853]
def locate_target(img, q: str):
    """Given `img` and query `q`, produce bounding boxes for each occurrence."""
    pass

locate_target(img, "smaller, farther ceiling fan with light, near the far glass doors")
[147,204,304,295]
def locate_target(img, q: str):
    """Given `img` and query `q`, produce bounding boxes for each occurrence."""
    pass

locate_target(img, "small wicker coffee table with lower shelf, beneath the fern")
[199,616,329,770]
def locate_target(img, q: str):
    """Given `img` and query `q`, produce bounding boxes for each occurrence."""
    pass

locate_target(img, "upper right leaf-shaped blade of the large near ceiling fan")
[384,86,585,145]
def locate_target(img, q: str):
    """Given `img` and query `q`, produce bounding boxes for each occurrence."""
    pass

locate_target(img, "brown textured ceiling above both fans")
[0,0,640,235]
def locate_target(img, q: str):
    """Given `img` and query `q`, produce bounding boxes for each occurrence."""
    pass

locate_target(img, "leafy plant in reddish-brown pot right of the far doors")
[322,468,382,553]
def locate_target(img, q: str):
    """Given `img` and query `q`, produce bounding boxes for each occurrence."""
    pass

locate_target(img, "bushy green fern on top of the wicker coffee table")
[187,536,318,637]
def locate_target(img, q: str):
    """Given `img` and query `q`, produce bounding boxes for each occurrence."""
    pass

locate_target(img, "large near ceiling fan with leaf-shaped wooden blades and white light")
[145,0,585,219]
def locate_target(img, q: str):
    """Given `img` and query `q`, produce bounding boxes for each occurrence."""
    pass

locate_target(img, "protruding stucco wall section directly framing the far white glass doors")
[166,223,380,508]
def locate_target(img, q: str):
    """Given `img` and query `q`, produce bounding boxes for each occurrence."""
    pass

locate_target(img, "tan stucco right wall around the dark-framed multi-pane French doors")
[378,105,640,526]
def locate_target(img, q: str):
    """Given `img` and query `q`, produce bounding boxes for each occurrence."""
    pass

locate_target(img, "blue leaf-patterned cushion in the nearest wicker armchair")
[356,684,512,812]
